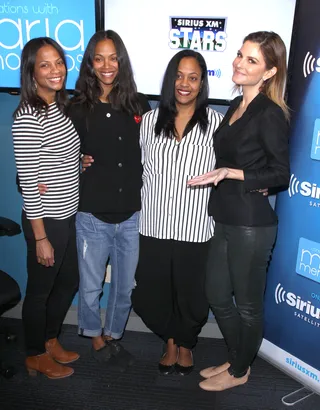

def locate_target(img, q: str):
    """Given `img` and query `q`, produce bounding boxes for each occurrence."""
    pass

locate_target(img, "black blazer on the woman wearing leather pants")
[209,93,290,226]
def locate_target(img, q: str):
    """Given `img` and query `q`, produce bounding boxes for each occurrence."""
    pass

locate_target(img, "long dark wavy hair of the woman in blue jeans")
[73,30,142,114]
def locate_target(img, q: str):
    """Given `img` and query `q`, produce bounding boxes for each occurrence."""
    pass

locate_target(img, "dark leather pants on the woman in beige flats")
[206,223,277,377]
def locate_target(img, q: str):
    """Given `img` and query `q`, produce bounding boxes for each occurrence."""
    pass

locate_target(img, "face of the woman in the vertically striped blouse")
[175,57,202,106]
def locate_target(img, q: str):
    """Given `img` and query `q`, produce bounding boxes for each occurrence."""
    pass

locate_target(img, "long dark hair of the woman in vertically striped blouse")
[155,50,209,138]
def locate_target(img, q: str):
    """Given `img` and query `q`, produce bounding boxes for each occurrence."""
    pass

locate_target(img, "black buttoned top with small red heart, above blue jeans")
[69,94,150,223]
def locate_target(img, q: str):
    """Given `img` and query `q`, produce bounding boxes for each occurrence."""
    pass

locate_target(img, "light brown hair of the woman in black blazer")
[243,31,290,120]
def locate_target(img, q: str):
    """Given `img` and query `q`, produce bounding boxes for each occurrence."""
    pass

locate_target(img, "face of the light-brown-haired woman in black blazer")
[232,41,275,89]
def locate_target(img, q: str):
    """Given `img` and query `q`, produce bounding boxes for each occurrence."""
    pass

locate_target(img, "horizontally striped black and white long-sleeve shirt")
[12,103,80,219]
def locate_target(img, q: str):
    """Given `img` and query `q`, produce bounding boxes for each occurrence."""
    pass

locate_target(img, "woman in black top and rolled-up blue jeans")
[69,30,150,370]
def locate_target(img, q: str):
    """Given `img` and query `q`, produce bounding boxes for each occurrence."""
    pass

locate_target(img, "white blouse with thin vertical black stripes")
[140,108,222,242]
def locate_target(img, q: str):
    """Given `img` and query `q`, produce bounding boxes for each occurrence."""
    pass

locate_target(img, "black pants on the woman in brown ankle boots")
[22,212,79,356]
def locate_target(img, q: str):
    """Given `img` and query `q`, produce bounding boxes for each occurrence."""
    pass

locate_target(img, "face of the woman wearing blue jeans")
[93,39,119,89]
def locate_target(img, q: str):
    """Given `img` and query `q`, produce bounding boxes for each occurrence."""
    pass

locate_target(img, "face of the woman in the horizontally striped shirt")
[33,45,66,104]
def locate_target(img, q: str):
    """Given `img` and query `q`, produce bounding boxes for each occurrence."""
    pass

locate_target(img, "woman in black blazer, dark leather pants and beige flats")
[188,32,290,391]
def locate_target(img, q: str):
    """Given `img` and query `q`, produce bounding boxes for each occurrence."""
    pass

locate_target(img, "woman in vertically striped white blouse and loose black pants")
[132,50,221,375]
